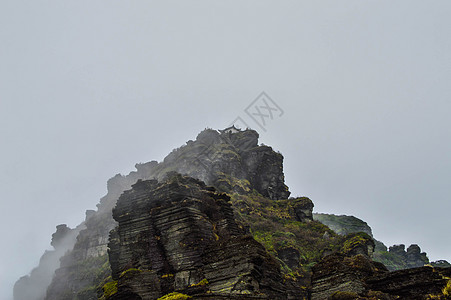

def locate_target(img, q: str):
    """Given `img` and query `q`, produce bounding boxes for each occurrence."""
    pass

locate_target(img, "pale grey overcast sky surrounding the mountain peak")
[0,0,451,299]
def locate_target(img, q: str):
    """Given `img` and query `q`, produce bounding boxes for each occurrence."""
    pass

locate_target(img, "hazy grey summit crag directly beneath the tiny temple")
[151,129,290,199]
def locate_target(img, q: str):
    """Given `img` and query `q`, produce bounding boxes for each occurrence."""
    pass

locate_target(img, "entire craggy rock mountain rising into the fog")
[14,129,451,300]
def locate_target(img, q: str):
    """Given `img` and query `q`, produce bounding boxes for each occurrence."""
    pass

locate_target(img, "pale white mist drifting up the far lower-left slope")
[13,224,82,300]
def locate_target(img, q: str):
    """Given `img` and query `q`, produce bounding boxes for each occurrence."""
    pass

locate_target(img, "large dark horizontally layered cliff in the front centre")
[108,175,301,300]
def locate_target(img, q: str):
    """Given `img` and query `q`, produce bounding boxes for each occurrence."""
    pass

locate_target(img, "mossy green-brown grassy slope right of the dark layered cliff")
[231,191,344,277]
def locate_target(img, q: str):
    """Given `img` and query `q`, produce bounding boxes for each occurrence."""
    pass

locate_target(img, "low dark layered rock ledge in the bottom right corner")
[312,247,451,300]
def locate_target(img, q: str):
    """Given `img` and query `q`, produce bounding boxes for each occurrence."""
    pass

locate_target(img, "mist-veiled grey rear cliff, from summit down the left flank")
[15,129,290,300]
